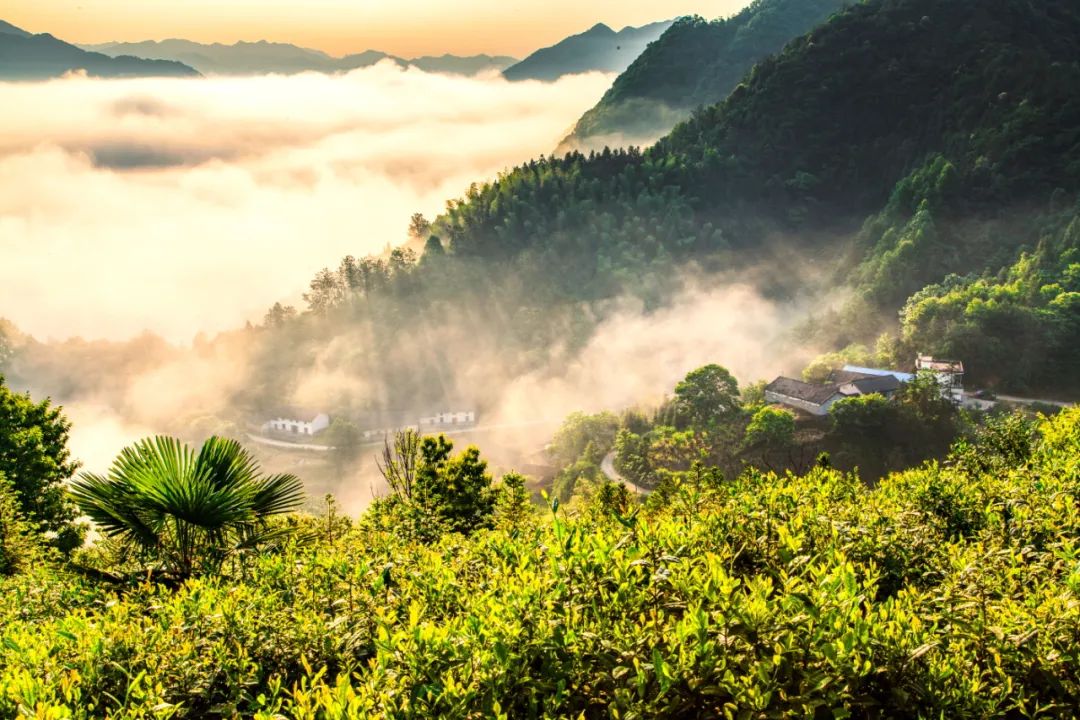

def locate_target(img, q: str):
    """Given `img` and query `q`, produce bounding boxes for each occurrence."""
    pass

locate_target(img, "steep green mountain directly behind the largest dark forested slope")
[559,0,853,151]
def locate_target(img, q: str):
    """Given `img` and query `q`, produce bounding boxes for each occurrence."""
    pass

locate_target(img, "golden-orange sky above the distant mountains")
[6,0,748,57]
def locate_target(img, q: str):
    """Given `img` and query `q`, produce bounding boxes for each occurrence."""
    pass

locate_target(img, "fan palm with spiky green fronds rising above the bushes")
[70,436,303,580]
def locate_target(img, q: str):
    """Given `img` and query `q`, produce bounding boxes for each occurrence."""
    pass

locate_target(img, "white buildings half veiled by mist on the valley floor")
[262,407,476,440]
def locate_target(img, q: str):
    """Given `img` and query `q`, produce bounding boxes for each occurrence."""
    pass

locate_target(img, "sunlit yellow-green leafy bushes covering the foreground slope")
[0,410,1080,718]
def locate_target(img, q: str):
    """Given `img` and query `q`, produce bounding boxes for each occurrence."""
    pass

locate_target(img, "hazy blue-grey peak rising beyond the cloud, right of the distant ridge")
[502,21,671,81]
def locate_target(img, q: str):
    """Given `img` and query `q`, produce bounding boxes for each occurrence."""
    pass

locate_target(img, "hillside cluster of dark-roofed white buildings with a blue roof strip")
[765,355,963,416]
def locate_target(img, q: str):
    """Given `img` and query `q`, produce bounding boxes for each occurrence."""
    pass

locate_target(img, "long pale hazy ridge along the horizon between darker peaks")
[82,39,516,76]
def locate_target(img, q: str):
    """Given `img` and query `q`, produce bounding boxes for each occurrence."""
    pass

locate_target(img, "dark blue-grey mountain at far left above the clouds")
[0,23,199,80]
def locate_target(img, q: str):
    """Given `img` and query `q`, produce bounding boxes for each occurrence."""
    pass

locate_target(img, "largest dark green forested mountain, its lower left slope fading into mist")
[247,0,1080,410]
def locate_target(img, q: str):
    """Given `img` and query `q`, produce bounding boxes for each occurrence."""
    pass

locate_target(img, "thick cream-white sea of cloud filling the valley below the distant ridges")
[0,64,610,342]
